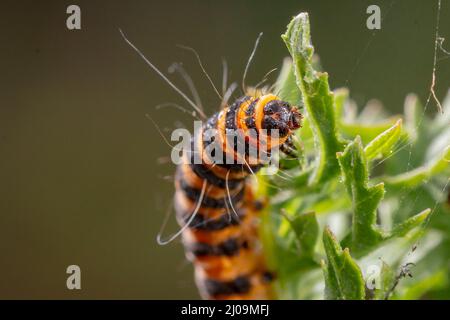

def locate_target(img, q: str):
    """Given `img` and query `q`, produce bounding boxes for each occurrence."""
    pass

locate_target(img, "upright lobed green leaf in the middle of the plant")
[337,137,384,252]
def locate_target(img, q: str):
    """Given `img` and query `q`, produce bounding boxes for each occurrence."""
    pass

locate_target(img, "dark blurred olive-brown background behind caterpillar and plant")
[0,0,450,299]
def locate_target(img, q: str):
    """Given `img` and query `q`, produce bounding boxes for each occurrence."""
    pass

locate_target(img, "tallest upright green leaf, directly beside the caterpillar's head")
[282,13,343,184]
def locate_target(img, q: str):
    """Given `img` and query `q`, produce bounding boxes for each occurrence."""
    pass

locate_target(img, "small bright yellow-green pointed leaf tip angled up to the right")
[364,119,402,160]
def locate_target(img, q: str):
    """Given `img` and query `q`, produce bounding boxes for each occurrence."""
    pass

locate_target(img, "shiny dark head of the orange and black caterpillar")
[261,100,302,137]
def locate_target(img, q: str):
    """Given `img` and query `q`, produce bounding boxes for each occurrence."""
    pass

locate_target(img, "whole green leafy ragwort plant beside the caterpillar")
[258,13,450,299]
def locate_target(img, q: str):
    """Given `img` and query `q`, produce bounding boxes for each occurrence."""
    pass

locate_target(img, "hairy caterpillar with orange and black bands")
[174,94,301,299]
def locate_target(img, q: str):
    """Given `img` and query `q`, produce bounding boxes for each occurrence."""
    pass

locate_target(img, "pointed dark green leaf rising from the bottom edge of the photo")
[322,228,365,300]
